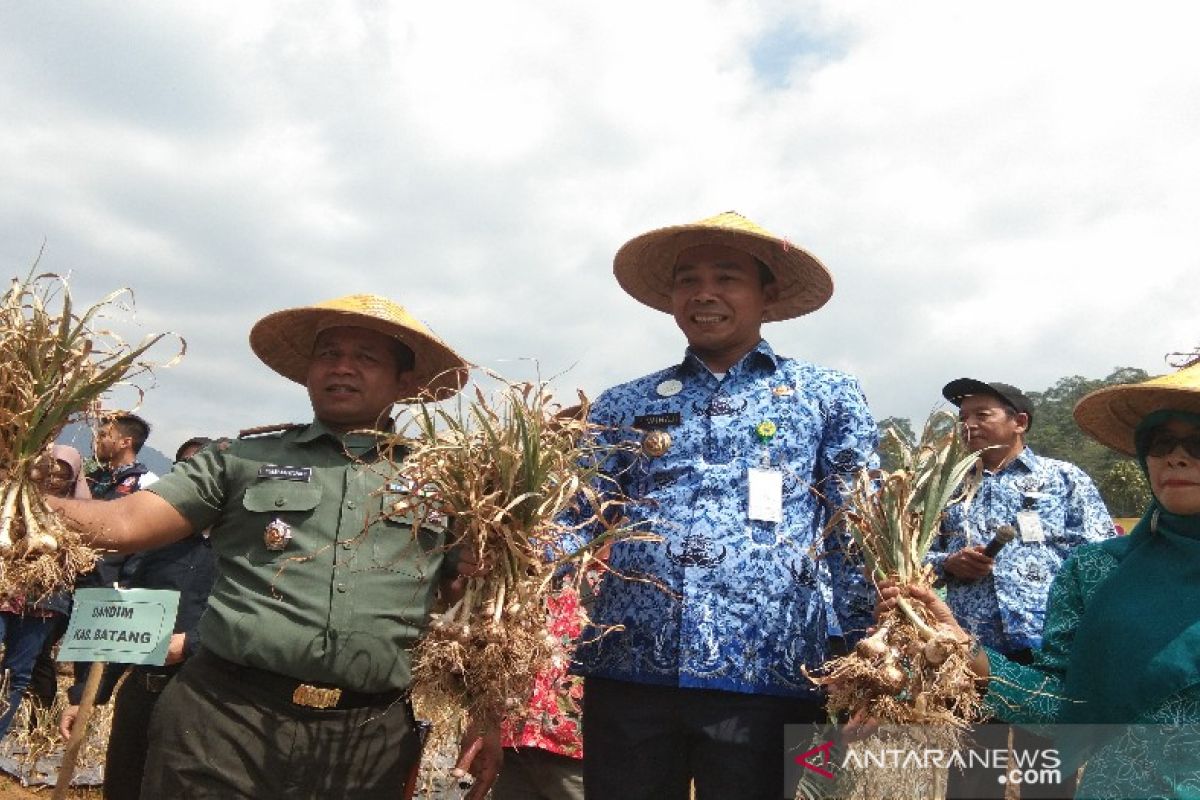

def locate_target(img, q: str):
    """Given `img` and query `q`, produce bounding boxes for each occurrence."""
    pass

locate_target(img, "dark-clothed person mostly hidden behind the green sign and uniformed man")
[59,437,216,800]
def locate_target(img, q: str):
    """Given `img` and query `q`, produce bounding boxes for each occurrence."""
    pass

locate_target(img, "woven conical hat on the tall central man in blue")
[612,211,833,323]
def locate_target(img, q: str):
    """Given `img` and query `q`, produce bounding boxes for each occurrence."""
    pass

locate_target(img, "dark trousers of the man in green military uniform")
[142,650,419,800]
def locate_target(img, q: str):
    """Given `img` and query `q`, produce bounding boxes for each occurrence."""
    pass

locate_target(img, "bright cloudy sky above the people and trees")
[0,0,1200,452]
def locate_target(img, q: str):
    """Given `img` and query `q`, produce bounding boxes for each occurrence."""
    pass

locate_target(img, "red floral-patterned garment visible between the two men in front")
[500,588,583,758]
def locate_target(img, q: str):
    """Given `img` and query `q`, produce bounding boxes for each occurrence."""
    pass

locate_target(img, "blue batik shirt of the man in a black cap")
[926,447,1116,654]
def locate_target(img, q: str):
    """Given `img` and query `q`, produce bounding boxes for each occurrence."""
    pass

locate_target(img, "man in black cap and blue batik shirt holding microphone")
[926,378,1116,663]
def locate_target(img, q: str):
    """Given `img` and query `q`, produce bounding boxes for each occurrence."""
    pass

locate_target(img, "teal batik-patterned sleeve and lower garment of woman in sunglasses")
[986,546,1200,800]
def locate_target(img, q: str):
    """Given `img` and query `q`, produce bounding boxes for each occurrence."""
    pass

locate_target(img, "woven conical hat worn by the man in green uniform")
[250,294,470,401]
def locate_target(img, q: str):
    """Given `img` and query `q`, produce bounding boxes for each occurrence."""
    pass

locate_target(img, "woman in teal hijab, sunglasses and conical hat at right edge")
[881,362,1200,798]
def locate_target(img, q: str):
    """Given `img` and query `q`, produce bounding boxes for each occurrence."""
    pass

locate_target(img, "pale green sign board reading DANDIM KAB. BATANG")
[59,589,179,664]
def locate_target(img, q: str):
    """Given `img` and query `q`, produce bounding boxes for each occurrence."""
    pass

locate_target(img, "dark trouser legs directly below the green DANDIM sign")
[104,668,170,800]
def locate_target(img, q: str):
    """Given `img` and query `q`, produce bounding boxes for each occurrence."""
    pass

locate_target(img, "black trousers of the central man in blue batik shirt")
[583,678,824,800]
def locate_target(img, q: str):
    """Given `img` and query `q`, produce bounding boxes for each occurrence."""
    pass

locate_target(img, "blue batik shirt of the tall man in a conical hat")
[576,342,877,697]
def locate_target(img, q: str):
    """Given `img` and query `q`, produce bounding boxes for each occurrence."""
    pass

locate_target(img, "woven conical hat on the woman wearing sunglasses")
[1075,363,1200,456]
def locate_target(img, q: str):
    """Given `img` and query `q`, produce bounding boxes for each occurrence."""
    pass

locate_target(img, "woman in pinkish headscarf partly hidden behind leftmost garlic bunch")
[0,445,91,738]
